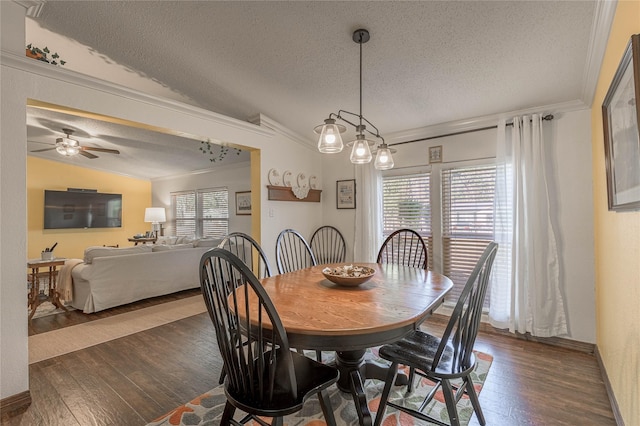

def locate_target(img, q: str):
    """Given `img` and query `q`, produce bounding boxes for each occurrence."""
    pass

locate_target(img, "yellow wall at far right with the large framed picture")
[591,1,640,425]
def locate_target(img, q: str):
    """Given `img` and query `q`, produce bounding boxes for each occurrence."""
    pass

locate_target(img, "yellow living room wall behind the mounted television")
[27,157,151,259]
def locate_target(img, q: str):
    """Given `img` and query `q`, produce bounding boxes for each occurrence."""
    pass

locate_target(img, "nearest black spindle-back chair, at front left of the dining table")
[200,248,340,425]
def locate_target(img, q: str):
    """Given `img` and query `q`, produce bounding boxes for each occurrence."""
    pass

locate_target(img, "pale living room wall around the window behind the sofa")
[151,162,251,235]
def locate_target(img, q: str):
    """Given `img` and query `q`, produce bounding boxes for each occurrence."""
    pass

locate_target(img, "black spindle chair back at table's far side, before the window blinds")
[376,228,429,269]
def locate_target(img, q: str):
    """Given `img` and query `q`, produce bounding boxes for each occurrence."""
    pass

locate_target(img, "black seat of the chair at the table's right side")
[379,330,476,379]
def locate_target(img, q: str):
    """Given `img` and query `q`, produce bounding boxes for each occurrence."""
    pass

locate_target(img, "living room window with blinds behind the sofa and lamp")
[171,188,229,238]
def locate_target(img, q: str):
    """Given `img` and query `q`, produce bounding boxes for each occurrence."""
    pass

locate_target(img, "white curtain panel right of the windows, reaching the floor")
[489,114,567,337]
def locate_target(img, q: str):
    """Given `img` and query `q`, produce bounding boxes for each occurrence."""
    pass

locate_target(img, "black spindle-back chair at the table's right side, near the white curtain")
[375,242,498,426]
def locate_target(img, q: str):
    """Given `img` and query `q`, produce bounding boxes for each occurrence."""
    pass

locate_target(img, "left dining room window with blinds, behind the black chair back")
[382,173,433,269]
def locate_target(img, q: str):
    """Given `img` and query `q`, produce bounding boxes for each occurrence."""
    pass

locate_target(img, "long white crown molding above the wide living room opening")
[0,50,273,137]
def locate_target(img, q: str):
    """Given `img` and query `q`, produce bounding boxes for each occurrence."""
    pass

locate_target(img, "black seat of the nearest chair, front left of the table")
[225,349,340,417]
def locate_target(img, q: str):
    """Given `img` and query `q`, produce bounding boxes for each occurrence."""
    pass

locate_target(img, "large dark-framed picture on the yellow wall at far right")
[602,34,640,212]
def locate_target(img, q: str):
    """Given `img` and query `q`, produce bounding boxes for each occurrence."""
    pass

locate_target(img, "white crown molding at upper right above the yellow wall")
[582,0,618,105]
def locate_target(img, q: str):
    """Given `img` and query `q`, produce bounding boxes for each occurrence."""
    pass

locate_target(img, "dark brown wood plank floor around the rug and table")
[2,291,616,426]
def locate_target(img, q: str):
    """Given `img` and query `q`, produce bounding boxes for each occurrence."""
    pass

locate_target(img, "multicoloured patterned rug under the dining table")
[147,349,493,426]
